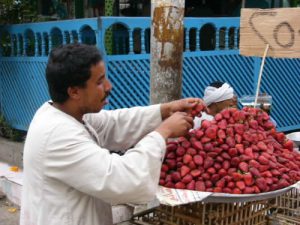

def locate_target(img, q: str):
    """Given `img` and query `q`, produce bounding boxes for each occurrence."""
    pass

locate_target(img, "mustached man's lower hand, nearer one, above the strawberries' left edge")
[155,112,194,139]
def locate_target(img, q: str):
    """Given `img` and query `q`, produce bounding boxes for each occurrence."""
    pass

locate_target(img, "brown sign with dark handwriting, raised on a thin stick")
[240,8,300,58]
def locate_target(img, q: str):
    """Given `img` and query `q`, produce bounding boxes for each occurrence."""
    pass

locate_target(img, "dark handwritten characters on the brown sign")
[248,11,300,50]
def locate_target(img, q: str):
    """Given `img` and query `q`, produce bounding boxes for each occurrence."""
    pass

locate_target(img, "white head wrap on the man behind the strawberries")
[203,83,234,106]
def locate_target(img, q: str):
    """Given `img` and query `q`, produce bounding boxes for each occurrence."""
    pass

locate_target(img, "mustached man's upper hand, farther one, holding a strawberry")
[160,98,204,120]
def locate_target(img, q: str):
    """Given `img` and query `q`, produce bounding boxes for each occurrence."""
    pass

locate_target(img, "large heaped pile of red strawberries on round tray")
[159,108,300,194]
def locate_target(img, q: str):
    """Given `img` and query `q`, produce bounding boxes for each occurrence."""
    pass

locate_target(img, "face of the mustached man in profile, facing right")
[80,61,112,114]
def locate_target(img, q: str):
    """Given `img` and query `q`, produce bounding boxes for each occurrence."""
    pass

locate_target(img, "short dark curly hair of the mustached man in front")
[46,44,102,103]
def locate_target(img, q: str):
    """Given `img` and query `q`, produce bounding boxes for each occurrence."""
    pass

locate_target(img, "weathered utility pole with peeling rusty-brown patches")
[150,0,185,104]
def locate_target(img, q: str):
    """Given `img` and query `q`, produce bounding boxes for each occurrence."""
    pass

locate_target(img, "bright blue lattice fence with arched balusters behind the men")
[0,17,300,131]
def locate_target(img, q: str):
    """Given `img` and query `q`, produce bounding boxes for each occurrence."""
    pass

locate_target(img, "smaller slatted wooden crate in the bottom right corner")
[270,188,300,225]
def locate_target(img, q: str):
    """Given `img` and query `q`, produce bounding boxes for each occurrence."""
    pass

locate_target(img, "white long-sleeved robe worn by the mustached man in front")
[20,103,166,225]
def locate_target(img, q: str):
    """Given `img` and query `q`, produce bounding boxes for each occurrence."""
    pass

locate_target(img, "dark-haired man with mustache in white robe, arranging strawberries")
[20,44,201,225]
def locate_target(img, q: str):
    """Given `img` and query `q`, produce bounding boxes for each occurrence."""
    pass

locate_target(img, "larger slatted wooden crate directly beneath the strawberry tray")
[133,200,270,225]
